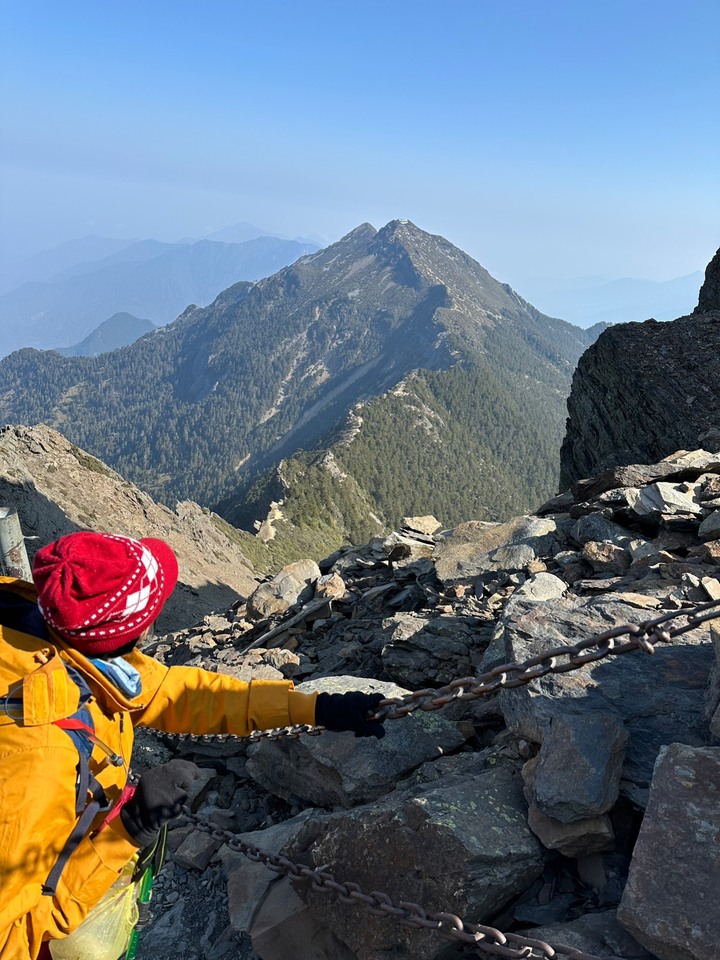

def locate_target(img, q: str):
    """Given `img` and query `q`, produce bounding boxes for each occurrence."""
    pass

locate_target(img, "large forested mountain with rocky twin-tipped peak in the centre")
[0,221,595,560]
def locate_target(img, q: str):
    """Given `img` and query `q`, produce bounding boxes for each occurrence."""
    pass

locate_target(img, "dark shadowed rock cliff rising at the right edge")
[560,278,720,490]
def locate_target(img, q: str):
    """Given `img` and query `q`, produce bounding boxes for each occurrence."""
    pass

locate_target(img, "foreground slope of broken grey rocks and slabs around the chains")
[129,446,720,960]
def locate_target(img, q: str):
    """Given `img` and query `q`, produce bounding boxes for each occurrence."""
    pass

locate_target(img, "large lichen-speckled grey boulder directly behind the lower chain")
[288,762,543,960]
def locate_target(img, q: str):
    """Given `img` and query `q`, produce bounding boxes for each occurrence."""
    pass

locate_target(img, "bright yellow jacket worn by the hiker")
[0,577,316,960]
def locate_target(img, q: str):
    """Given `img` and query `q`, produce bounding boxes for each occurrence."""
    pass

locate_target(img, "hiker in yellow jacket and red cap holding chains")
[0,532,385,960]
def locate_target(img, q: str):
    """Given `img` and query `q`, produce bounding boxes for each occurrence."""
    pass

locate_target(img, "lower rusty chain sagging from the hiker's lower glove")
[182,807,622,960]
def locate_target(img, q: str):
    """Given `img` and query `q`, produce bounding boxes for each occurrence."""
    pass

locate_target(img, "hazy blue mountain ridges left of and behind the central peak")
[0,231,318,356]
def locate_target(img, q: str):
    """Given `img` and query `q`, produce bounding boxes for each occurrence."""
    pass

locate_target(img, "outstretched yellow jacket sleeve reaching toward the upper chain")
[127,651,317,737]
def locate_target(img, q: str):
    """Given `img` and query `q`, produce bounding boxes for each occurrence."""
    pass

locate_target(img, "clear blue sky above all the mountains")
[0,0,720,284]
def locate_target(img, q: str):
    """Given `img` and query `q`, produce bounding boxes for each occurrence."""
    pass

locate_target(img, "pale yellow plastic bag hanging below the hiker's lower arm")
[48,859,139,960]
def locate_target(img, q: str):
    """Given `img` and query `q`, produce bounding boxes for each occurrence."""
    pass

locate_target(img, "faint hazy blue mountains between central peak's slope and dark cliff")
[518,270,703,327]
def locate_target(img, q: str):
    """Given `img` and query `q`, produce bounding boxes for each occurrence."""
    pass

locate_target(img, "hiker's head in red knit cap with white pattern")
[33,532,178,657]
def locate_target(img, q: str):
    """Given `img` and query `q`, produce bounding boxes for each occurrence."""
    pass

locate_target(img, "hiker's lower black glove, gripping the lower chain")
[120,760,200,848]
